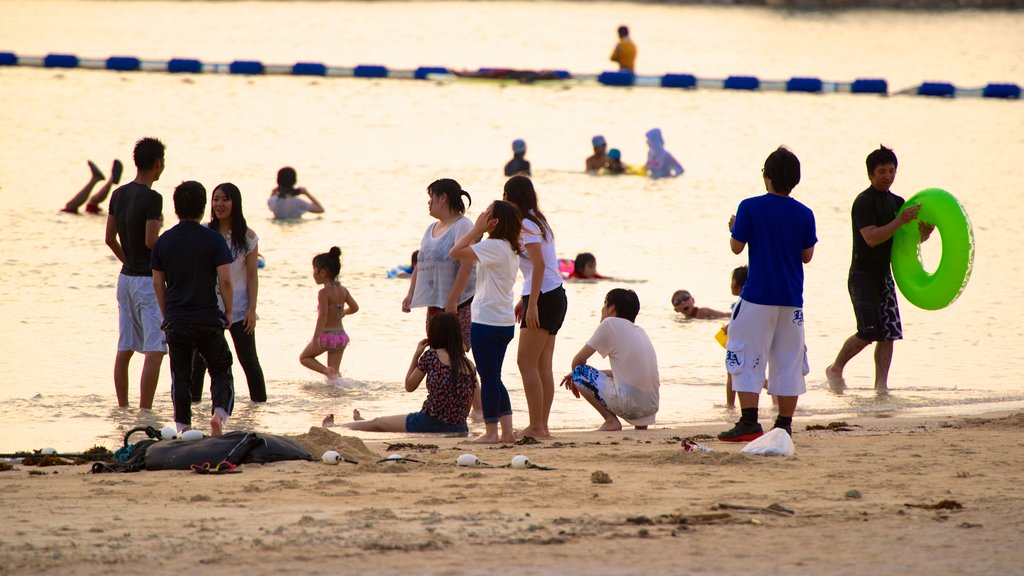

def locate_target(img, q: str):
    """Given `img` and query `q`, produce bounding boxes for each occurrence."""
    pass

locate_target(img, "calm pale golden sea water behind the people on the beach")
[0,0,1024,452]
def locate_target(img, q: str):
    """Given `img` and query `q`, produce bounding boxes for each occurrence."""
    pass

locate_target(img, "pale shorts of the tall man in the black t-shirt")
[118,274,167,354]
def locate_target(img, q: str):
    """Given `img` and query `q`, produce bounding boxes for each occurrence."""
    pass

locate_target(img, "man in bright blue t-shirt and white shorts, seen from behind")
[718,147,818,442]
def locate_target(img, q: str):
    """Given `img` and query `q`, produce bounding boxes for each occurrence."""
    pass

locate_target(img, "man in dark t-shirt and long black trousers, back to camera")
[153,181,234,436]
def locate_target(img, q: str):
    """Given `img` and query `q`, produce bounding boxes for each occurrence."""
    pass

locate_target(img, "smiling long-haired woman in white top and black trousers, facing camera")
[191,182,266,402]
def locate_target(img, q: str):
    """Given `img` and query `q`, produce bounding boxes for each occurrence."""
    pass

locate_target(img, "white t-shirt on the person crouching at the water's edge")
[587,316,660,425]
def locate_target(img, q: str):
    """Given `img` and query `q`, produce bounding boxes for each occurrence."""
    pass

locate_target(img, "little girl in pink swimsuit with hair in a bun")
[299,246,359,381]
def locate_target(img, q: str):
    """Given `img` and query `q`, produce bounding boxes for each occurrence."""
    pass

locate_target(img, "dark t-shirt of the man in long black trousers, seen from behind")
[153,220,233,326]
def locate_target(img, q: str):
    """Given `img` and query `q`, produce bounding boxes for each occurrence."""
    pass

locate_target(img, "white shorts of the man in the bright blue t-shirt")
[725,298,810,396]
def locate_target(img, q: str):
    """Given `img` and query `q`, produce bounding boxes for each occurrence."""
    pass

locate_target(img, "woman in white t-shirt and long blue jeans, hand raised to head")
[451,201,521,444]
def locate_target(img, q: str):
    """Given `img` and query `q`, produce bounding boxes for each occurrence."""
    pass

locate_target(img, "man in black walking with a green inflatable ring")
[825,146,935,393]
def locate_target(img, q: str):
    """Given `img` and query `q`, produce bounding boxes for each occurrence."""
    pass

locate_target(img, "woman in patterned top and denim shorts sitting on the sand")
[324,313,476,436]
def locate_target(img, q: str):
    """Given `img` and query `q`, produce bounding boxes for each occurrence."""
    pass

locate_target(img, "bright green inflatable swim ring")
[892,188,974,310]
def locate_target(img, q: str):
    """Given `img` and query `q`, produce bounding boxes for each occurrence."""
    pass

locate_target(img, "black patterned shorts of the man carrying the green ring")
[847,269,903,342]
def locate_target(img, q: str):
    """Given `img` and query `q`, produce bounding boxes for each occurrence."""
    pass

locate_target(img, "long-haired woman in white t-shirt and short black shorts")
[504,172,568,438]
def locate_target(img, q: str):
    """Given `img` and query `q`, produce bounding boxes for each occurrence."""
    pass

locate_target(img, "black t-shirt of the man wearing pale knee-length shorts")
[111,182,164,276]
